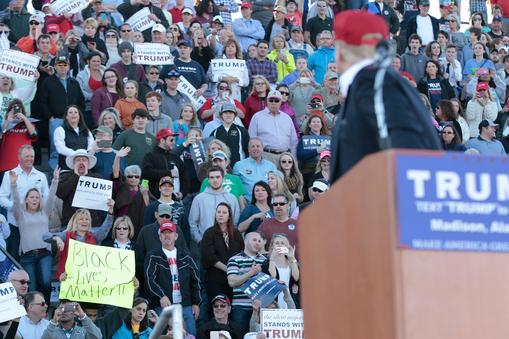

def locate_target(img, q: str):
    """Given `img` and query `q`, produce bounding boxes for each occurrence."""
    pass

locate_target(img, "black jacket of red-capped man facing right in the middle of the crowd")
[141,146,189,197]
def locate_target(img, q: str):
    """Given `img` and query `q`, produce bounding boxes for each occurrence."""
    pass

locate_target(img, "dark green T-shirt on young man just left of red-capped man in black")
[113,129,157,167]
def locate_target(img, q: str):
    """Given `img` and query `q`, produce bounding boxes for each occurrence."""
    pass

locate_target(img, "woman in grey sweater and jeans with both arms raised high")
[9,167,60,300]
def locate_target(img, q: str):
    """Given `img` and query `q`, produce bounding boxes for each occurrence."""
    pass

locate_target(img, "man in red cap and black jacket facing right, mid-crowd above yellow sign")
[141,128,189,199]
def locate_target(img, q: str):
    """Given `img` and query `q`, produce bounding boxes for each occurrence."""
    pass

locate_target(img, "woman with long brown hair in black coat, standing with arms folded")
[201,202,244,299]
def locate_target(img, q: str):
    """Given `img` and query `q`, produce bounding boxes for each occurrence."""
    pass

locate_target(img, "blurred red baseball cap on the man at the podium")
[334,10,389,46]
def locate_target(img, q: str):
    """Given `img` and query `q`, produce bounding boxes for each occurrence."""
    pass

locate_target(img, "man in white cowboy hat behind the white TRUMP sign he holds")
[57,149,104,225]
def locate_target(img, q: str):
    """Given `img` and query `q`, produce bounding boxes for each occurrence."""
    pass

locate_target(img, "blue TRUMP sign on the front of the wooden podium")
[395,152,509,252]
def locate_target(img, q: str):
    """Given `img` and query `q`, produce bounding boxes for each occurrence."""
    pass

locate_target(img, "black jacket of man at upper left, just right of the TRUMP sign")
[40,74,85,119]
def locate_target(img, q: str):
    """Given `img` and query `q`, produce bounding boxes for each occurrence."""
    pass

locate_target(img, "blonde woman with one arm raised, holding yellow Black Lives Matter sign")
[42,199,115,281]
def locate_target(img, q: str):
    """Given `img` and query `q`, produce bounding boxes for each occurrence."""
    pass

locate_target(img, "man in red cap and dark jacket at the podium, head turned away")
[330,10,441,183]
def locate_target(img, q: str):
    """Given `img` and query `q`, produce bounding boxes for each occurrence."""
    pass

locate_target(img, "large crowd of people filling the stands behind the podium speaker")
[0,0,509,339]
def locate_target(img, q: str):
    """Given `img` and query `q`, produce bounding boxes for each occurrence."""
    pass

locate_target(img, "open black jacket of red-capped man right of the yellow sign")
[145,247,201,306]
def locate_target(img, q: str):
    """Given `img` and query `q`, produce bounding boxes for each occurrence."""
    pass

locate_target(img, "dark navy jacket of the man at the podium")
[330,65,441,182]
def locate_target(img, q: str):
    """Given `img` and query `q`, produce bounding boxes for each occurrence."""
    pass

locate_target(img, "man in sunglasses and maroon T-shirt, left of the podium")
[258,193,298,253]
